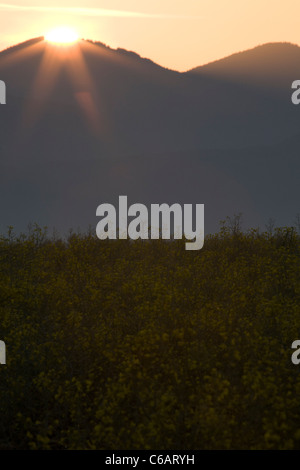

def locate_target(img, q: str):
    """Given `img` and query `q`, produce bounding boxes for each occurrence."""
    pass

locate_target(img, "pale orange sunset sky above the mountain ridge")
[0,0,300,70]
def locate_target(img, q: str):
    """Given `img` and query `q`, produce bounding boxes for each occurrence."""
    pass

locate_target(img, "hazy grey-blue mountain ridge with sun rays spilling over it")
[0,38,300,231]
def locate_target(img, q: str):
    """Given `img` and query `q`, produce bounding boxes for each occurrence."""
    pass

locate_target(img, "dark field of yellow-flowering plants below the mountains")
[0,225,300,450]
